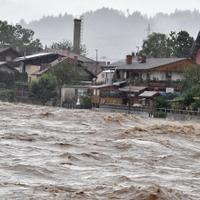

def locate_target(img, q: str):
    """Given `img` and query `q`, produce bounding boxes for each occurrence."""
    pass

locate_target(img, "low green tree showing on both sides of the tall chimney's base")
[50,40,87,56]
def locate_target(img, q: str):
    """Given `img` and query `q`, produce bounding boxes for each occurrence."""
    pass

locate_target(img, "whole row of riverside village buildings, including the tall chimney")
[0,19,200,107]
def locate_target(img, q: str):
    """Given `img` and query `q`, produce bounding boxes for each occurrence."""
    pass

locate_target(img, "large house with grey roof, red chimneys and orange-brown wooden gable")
[111,55,193,90]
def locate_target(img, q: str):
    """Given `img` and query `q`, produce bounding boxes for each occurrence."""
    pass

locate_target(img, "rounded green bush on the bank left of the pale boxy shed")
[31,74,57,104]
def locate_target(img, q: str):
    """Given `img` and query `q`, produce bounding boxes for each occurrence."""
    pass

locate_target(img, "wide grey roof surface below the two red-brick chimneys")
[110,58,188,70]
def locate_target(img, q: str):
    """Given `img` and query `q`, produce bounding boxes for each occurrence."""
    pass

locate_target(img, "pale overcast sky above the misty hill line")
[0,0,200,22]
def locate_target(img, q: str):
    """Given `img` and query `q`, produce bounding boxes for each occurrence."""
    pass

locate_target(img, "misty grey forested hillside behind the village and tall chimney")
[20,8,200,59]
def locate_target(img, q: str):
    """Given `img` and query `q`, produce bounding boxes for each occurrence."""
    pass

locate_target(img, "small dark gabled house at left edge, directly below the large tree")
[0,47,20,62]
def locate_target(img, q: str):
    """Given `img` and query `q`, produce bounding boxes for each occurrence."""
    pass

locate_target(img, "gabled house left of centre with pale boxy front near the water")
[40,57,96,106]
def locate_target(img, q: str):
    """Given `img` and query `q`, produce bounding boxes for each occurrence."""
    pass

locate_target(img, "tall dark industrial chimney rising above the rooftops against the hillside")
[73,19,82,54]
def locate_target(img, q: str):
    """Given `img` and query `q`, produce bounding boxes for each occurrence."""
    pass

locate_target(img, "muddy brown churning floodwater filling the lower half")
[0,103,200,200]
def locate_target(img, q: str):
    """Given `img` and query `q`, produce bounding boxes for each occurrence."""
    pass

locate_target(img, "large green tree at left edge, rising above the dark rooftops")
[0,21,42,54]
